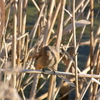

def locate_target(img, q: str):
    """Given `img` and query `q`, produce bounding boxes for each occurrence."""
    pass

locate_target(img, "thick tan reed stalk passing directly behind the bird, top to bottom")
[47,0,66,100]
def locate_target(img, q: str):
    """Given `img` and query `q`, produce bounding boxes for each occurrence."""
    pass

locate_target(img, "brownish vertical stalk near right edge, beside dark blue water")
[89,0,94,100]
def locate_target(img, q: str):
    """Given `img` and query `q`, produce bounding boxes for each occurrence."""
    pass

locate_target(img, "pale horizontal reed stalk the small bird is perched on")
[0,65,100,79]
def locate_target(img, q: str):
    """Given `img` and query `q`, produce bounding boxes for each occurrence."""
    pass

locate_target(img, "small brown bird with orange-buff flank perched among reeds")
[36,46,59,70]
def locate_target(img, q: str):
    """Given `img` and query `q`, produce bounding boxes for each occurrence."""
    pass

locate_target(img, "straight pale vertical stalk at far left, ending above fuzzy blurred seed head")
[12,0,17,88]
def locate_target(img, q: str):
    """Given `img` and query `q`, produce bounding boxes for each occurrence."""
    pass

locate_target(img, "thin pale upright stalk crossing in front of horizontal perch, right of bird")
[73,0,79,100]
